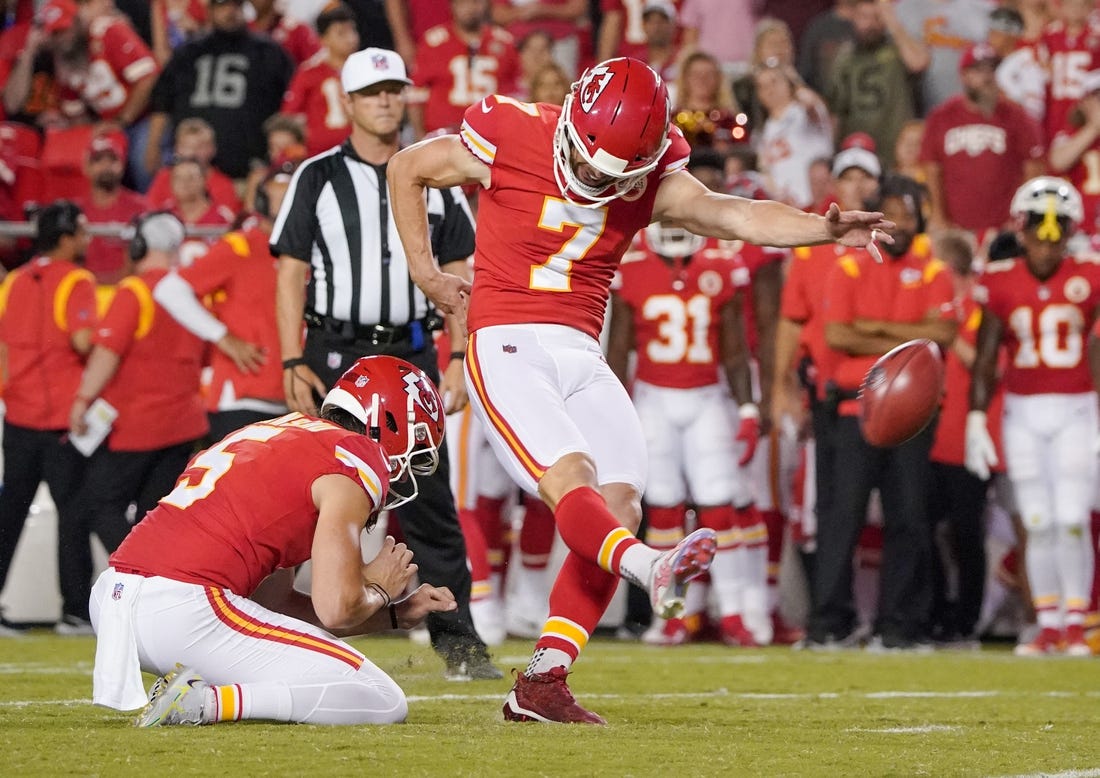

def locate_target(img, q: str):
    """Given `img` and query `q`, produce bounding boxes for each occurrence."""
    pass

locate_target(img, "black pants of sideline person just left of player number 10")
[928,462,987,636]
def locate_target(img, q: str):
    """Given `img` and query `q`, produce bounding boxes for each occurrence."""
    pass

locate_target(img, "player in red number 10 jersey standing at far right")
[966,176,1100,656]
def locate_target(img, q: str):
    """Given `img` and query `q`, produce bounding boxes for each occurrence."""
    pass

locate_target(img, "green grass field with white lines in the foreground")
[0,631,1100,777]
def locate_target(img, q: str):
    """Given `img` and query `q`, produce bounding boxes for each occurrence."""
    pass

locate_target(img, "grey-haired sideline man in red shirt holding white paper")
[68,211,209,554]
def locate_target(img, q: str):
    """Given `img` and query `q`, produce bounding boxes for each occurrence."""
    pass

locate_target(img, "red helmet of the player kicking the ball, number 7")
[553,57,671,207]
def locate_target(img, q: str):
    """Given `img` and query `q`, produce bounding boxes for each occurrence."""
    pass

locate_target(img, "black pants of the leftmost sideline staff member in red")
[0,421,91,618]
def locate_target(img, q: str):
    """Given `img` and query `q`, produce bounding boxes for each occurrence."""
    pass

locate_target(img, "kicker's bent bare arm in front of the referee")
[386,135,490,316]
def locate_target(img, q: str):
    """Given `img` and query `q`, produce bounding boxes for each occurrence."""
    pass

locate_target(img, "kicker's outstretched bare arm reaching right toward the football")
[653,172,894,248]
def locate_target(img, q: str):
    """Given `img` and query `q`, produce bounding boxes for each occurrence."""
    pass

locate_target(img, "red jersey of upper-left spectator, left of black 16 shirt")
[57,15,161,120]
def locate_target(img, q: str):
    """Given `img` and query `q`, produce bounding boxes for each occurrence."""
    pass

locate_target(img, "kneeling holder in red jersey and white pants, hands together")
[91,357,457,726]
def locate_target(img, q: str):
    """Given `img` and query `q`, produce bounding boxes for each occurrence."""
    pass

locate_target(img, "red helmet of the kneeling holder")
[321,357,444,508]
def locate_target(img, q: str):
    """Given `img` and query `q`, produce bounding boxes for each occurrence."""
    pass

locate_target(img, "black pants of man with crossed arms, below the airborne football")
[809,416,935,640]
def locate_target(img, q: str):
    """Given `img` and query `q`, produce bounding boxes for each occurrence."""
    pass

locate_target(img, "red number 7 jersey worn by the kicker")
[460,95,690,339]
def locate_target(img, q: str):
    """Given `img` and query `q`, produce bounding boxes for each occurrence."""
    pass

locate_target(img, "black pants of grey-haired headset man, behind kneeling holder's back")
[77,440,197,556]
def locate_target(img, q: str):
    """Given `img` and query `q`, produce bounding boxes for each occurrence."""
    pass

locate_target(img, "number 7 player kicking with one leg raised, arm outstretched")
[387,58,893,723]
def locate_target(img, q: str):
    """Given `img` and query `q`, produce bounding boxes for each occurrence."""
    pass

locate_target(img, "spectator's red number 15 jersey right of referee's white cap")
[413,24,519,132]
